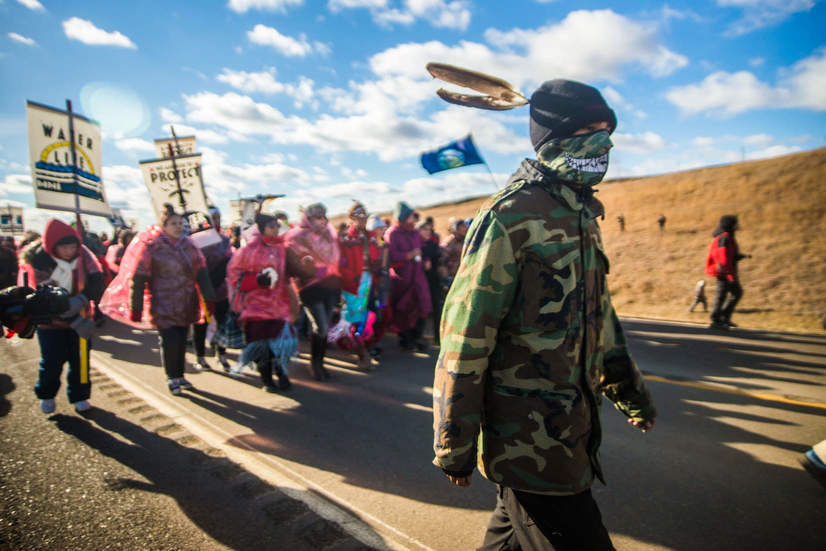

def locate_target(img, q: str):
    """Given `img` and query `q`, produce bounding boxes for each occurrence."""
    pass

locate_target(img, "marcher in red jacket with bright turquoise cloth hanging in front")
[338,202,381,370]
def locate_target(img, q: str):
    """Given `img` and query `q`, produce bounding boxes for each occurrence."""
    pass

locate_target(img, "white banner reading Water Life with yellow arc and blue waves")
[26,101,112,217]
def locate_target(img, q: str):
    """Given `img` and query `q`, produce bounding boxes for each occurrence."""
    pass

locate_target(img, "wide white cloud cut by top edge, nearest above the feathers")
[327,0,471,31]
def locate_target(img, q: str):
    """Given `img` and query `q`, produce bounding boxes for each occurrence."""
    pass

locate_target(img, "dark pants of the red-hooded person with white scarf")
[34,329,92,404]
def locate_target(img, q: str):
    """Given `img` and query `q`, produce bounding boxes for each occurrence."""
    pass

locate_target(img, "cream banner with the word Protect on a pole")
[138,153,209,225]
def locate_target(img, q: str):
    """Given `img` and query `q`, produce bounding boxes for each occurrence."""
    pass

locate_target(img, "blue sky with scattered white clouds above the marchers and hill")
[0,0,826,230]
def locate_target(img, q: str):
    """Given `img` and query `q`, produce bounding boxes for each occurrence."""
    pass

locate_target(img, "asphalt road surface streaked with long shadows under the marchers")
[0,320,826,551]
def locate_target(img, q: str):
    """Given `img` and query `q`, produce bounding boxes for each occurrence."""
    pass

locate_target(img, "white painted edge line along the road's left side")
[92,350,435,551]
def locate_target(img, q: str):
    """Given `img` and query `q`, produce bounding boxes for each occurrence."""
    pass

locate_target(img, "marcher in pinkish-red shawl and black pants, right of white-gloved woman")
[285,203,341,380]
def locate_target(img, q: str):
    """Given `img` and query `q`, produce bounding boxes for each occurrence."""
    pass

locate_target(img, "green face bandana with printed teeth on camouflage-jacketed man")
[537,130,614,186]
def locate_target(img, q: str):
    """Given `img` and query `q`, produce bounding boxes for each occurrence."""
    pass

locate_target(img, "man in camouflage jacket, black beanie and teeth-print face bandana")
[433,80,656,550]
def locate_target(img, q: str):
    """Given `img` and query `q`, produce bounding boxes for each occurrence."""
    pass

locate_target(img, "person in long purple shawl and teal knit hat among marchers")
[385,202,432,352]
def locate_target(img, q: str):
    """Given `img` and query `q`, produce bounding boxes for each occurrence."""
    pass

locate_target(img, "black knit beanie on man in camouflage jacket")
[530,79,617,151]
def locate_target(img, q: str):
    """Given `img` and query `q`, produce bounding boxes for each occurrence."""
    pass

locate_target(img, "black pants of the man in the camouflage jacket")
[479,486,615,551]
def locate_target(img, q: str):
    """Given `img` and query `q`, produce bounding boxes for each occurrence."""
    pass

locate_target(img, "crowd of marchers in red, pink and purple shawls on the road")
[0,198,469,406]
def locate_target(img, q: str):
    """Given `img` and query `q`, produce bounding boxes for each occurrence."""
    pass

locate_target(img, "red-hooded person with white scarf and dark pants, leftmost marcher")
[18,219,104,413]
